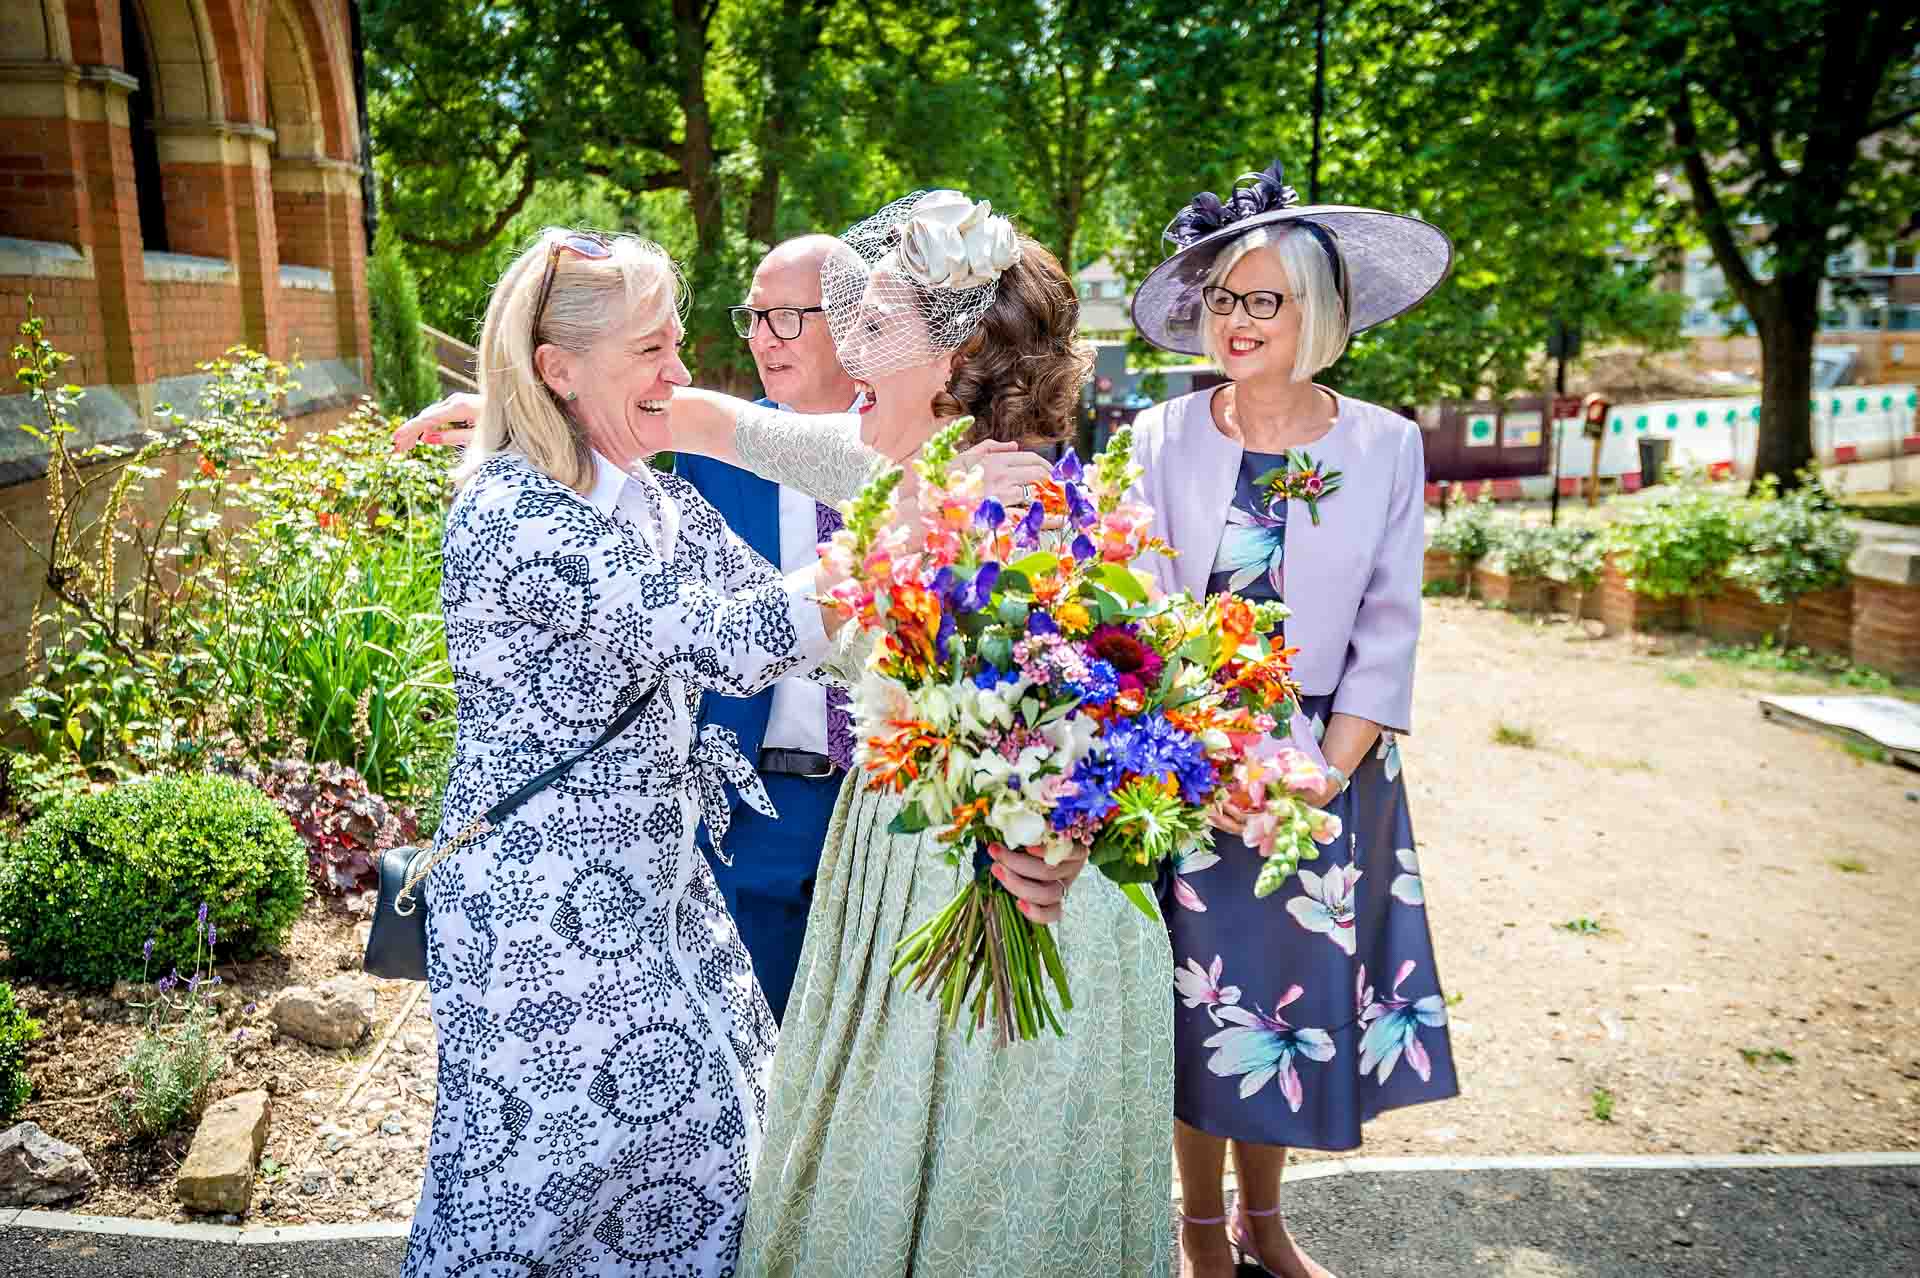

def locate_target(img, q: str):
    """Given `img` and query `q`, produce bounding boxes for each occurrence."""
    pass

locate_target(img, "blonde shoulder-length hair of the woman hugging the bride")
[453,226,687,493]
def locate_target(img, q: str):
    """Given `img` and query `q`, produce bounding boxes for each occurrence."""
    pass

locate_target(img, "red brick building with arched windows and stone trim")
[0,0,371,472]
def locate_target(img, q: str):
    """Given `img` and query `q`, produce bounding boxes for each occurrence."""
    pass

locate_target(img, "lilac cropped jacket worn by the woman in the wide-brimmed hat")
[1133,390,1427,733]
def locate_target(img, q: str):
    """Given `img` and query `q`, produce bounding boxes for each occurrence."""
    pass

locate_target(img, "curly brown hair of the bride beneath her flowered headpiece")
[933,236,1092,447]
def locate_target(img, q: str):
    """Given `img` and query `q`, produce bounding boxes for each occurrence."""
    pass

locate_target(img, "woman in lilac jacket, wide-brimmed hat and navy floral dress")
[1133,165,1457,1278]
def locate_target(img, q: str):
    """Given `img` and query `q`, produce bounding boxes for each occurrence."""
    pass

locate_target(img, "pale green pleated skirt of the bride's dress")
[737,783,1173,1278]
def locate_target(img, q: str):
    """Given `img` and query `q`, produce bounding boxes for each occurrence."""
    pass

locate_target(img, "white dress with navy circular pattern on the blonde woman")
[403,455,826,1278]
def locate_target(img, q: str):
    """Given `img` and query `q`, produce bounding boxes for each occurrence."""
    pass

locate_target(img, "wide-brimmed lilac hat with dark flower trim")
[1133,165,1453,355]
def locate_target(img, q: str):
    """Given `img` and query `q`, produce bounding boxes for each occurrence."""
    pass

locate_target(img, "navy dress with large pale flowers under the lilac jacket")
[1162,453,1459,1149]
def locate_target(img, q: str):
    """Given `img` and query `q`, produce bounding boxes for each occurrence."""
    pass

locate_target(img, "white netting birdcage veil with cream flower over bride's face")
[820,190,1020,382]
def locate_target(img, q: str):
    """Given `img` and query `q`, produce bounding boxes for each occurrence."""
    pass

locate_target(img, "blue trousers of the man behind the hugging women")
[712,759,845,1021]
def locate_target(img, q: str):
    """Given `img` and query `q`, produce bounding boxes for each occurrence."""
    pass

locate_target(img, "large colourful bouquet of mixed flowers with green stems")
[822,418,1340,1044]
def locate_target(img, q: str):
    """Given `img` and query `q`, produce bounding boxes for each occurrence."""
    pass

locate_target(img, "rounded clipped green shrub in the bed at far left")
[0,775,307,986]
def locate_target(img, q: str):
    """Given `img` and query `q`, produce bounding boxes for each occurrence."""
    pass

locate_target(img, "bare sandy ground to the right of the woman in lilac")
[1302,599,1920,1159]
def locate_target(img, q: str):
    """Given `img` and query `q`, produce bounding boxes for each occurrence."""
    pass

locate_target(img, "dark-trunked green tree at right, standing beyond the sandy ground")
[1512,0,1920,485]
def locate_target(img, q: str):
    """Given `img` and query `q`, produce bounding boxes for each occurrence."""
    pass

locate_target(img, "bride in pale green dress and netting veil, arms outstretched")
[396,192,1173,1278]
